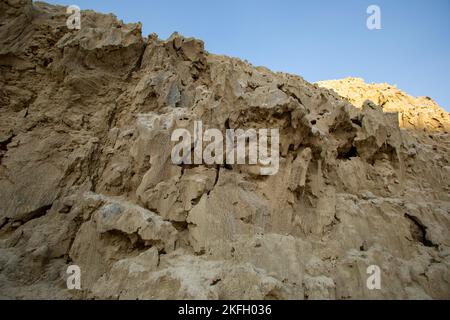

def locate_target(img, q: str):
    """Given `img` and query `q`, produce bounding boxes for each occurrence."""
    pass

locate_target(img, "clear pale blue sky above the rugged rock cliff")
[44,0,450,111]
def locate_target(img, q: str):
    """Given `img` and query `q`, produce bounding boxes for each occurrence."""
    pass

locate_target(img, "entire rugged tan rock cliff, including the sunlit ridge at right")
[0,0,450,299]
